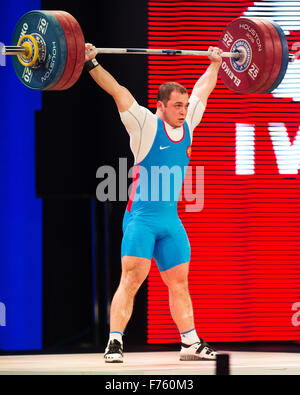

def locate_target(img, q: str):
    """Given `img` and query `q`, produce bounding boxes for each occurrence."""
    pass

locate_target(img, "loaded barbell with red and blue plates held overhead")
[2,10,295,94]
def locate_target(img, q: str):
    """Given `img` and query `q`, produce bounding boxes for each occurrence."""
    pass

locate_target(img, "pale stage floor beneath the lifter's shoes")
[0,350,300,375]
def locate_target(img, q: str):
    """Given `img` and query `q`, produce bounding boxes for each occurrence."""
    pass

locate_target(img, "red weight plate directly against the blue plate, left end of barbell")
[47,11,77,90]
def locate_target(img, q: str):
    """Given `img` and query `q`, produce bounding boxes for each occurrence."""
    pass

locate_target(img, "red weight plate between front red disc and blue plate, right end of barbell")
[246,18,282,93]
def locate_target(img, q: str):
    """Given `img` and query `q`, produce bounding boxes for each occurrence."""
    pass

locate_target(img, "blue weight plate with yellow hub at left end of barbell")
[12,10,67,90]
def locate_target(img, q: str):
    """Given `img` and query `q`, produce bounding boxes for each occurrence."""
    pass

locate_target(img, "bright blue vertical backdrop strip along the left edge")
[0,0,42,351]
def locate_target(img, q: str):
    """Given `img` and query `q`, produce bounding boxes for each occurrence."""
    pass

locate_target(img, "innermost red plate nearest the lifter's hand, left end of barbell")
[56,11,85,90]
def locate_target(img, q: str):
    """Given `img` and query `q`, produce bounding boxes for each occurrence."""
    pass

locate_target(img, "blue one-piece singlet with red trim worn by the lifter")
[121,118,191,271]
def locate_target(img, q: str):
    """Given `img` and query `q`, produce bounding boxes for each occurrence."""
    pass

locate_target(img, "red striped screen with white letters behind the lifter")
[148,0,300,343]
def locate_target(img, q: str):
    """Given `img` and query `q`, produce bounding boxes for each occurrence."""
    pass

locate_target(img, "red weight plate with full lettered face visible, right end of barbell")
[219,17,273,94]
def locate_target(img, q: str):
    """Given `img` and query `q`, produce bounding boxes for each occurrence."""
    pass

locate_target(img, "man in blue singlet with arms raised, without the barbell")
[85,44,223,362]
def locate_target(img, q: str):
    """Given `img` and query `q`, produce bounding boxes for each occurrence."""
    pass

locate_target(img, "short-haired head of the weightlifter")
[157,82,189,128]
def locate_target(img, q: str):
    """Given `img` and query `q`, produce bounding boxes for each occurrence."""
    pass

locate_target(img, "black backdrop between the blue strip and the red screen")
[36,0,147,352]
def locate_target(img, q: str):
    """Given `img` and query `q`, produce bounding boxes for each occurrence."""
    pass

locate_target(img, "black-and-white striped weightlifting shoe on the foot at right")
[180,339,216,361]
